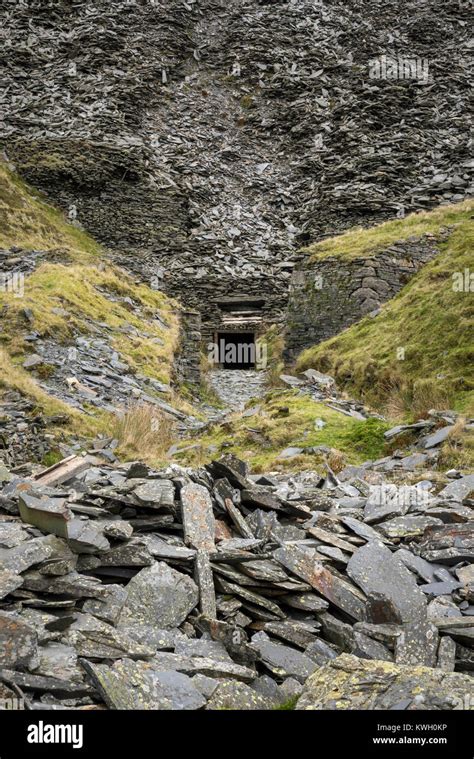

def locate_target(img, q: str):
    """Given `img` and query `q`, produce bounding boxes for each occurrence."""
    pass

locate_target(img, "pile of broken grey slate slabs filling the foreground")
[0,448,474,709]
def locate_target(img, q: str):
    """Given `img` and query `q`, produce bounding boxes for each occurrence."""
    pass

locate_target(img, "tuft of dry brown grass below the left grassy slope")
[112,403,175,464]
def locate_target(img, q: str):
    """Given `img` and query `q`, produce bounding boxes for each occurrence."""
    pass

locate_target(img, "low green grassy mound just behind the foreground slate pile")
[176,390,390,472]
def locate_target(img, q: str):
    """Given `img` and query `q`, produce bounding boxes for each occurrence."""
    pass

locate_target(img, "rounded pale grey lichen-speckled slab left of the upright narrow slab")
[119,562,199,629]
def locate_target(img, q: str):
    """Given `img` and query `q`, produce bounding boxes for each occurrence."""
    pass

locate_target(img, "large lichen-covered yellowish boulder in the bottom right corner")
[296,654,474,710]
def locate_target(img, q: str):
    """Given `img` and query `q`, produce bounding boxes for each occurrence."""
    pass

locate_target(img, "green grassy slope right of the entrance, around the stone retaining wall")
[297,201,474,417]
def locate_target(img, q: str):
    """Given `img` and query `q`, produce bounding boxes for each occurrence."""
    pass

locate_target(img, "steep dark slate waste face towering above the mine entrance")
[0,0,472,338]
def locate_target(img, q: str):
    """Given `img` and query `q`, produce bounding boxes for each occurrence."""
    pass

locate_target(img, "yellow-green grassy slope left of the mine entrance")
[0,164,179,442]
